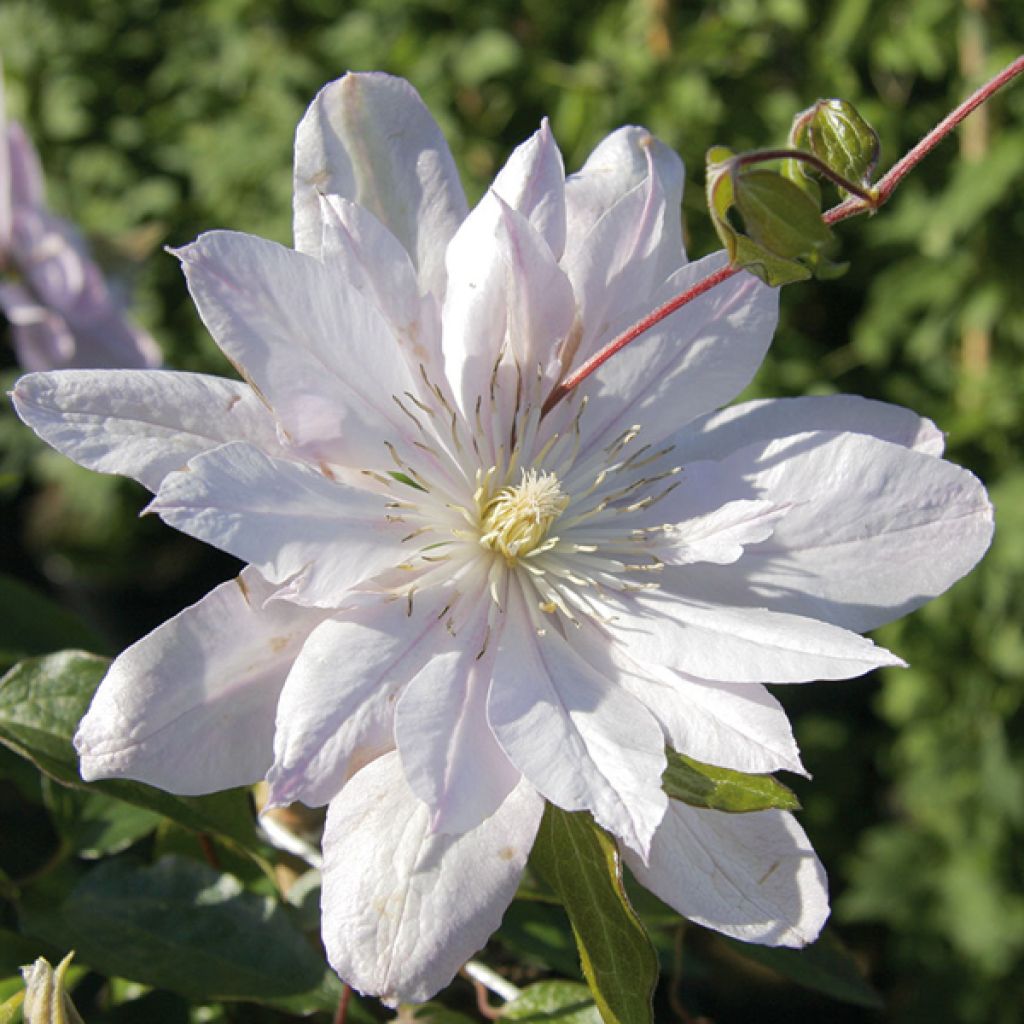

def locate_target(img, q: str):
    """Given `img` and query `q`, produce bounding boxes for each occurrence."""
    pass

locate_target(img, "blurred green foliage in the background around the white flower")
[0,0,1024,1024]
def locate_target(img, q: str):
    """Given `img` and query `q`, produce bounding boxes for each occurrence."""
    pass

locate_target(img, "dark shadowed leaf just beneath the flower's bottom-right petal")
[721,929,885,1010]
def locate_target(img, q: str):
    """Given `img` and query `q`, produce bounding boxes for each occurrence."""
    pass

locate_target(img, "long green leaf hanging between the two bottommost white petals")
[530,804,658,1024]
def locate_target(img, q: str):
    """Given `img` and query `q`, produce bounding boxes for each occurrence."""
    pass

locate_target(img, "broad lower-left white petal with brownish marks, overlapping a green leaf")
[75,569,323,796]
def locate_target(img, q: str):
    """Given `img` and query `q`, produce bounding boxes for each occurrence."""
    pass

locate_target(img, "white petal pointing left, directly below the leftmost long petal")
[147,441,404,607]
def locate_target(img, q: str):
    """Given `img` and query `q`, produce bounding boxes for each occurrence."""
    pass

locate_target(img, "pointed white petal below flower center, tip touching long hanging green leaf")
[487,590,666,856]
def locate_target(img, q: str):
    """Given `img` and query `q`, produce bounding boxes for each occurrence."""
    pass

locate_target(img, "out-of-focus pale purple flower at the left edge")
[0,74,161,370]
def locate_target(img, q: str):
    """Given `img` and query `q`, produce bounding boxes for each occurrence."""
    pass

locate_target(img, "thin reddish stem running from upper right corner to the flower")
[542,55,1024,416]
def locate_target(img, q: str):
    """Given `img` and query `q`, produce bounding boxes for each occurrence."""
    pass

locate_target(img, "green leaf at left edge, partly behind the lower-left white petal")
[0,651,262,853]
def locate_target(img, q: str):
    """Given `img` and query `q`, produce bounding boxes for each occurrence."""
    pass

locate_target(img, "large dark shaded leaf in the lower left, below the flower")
[22,857,324,999]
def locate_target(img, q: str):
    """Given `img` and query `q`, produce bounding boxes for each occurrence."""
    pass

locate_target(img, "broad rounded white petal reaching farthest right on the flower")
[669,432,992,631]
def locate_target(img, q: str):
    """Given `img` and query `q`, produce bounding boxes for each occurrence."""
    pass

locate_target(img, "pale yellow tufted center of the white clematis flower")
[474,469,569,565]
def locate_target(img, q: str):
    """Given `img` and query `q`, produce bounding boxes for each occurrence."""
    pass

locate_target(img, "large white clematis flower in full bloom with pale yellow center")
[14,75,992,1000]
